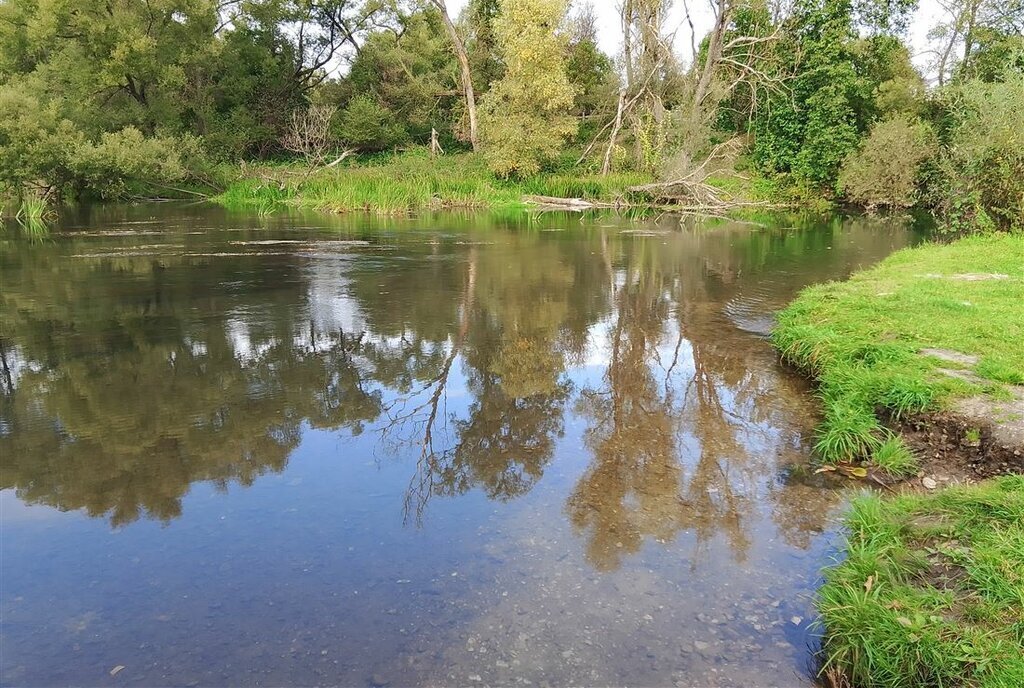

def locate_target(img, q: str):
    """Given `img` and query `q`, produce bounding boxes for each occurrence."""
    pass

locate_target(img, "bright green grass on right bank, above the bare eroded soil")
[772,234,1024,476]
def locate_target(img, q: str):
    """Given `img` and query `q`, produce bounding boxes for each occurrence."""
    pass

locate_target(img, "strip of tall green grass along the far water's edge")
[216,152,649,214]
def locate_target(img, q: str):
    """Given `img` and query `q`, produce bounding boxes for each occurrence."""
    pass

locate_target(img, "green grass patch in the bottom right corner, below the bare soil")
[818,476,1024,688]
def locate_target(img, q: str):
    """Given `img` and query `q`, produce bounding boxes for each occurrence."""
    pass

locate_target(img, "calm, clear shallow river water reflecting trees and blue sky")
[0,205,915,686]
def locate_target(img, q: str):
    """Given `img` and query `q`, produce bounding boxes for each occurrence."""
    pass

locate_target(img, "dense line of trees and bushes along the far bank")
[0,0,1024,228]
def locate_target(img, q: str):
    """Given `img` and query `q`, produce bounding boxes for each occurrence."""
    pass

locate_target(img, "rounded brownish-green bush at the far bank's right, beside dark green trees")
[839,117,937,208]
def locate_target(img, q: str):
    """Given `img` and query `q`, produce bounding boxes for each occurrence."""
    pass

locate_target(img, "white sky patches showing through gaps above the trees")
[447,0,939,78]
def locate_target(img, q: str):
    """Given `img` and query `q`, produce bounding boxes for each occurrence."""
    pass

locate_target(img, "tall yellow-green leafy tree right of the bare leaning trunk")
[480,0,577,176]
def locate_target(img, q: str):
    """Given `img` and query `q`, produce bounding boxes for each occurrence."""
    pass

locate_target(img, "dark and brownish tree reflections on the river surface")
[0,207,905,570]
